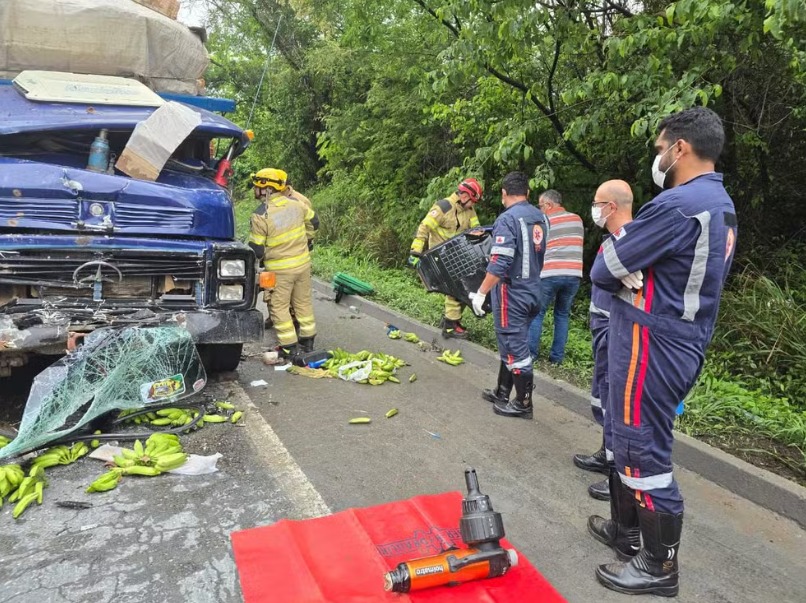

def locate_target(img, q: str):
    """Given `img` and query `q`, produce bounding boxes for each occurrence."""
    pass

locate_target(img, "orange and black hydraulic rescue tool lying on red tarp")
[384,469,518,593]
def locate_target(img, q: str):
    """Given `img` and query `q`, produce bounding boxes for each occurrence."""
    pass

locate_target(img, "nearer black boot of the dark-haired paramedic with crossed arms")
[596,507,683,597]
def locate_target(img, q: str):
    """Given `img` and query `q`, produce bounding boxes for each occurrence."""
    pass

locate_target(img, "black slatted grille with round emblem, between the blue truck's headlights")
[0,250,205,287]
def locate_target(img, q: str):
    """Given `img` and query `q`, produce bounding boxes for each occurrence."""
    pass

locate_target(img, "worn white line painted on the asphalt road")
[227,383,330,519]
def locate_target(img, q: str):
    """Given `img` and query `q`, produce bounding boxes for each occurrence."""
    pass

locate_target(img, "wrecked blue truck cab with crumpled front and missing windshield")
[0,78,263,376]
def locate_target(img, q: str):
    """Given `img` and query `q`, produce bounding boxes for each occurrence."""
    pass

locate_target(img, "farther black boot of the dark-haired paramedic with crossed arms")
[588,469,641,561]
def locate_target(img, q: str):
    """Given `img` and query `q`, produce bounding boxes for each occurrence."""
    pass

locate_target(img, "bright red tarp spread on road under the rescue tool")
[232,492,566,603]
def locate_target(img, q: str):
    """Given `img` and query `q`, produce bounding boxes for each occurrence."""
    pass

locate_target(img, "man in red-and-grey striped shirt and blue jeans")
[529,190,585,364]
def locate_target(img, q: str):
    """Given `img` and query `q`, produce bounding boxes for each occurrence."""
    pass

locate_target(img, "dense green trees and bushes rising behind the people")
[213,0,806,476]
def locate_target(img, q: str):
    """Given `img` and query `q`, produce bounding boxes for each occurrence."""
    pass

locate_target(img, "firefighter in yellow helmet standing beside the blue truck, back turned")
[249,168,319,358]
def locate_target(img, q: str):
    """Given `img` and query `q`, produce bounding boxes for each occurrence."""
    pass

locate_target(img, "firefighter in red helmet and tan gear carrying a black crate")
[408,178,482,339]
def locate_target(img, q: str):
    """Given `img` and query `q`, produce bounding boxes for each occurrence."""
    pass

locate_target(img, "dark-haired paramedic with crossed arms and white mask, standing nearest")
[588,107,737,597]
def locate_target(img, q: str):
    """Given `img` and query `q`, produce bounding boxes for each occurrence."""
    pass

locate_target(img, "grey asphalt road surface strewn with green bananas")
[0,295,806,603]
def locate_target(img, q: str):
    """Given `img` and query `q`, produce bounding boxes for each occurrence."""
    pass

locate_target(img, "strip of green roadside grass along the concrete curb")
[235,199,806,485]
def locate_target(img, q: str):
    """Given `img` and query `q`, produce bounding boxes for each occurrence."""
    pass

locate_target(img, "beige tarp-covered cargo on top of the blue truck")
[0,0,209,94]
